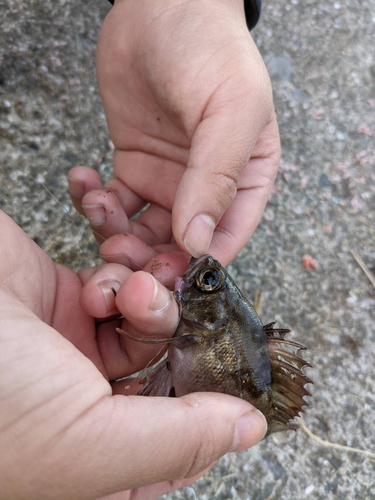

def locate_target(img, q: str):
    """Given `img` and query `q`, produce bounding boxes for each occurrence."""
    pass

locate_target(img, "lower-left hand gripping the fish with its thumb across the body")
[0,212,265,500]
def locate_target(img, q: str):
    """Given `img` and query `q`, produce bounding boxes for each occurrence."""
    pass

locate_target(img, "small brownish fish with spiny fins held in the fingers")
[118,255,312,436]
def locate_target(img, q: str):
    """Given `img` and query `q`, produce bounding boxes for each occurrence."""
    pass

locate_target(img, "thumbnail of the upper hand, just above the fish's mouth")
[183,214,215,257]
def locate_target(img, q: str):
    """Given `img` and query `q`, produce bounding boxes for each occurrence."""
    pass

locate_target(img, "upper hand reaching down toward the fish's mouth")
[69,0,280,265]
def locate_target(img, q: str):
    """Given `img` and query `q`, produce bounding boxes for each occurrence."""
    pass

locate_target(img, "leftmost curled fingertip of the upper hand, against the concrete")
[68,167,103,215]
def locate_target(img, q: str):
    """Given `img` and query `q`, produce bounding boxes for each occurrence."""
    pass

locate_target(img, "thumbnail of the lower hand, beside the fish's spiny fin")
[229,410,267,451]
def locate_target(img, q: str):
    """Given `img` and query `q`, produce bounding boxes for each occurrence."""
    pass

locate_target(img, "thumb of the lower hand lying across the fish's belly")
[71,393,266,497]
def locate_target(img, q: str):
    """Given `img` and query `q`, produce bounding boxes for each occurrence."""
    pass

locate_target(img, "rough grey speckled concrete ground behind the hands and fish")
[0,0,375,500]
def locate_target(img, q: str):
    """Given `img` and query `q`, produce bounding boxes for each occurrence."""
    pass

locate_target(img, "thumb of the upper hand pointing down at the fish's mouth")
[172,68,272,257]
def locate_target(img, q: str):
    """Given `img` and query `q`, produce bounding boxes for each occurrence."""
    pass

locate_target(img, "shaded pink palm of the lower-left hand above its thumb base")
[0,210,104,371]
